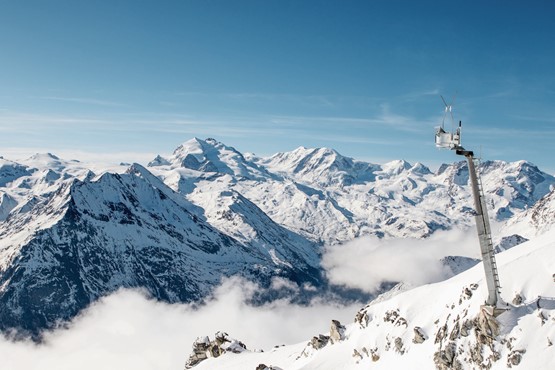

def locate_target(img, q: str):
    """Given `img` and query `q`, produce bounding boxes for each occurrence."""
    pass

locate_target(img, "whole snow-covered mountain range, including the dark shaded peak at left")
[0,138,555,337]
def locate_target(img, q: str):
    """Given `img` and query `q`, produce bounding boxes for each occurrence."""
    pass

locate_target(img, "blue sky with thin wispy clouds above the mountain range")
[0,0,555,173]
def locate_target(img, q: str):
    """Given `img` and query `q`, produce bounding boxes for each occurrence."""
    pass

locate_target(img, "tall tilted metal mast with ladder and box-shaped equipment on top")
[435,97,506,316]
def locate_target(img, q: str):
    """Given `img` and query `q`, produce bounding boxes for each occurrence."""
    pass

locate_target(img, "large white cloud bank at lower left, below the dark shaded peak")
[0,279,360,370]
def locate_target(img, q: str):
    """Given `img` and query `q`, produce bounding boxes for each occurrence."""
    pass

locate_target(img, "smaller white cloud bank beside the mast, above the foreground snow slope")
[322,230,479,293]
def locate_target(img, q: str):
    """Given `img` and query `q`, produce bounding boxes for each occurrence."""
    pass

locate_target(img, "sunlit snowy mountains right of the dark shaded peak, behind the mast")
[151,139,555,244]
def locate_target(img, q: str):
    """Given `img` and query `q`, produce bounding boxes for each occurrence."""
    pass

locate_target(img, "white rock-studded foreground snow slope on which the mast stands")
[194,230,555,370]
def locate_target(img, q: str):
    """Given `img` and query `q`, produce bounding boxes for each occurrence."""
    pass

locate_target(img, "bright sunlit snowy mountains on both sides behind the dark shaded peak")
[0,138,555,251]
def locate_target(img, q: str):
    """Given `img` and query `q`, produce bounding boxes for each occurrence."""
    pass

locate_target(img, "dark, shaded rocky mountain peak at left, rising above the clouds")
[0,167,322,339]
